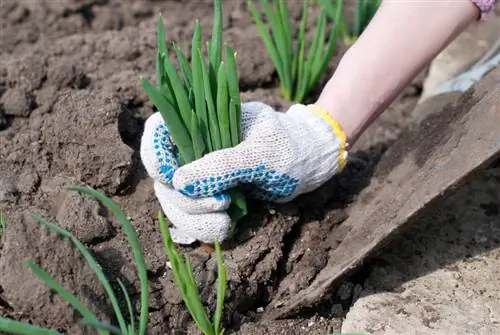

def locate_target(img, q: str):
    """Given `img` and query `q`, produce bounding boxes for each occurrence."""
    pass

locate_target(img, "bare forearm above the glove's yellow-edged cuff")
[317,0,479,146]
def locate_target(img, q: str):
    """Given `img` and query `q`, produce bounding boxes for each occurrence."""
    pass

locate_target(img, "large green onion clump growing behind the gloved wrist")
[248,0,342,102]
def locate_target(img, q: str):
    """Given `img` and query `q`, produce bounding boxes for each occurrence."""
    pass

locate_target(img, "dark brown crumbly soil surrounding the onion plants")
[0,0,420,335]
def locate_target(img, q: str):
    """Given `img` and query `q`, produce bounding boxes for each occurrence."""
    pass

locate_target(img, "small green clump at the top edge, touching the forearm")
[319,0,382,44]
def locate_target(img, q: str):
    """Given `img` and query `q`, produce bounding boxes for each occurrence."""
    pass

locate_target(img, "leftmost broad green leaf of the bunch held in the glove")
[140,76,195,163]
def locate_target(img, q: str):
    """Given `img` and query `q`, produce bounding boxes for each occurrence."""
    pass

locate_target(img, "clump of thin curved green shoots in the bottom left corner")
[0,186,149,335]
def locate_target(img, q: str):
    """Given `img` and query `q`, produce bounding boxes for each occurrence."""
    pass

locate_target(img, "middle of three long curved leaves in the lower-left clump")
[33,215,127,332]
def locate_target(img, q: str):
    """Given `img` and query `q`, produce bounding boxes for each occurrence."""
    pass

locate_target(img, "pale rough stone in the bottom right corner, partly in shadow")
[342,167,500,335]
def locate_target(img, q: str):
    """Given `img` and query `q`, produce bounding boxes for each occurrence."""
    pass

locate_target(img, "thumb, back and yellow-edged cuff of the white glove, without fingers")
[173,102,347,202]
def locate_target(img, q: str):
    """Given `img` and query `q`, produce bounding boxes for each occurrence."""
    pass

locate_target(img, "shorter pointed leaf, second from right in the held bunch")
[217,62,231,148]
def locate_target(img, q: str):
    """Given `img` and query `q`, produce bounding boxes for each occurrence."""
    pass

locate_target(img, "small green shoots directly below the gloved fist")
[158,212,227,335]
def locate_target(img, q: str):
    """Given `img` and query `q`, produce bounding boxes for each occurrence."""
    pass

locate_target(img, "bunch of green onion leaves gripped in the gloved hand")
[140,0,247,227]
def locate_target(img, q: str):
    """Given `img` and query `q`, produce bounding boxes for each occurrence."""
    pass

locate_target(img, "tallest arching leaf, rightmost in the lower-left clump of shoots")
[70,186,149,335]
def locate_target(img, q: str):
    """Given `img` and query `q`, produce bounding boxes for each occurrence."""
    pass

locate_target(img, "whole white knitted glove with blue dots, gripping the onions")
[141,102,347,243]
